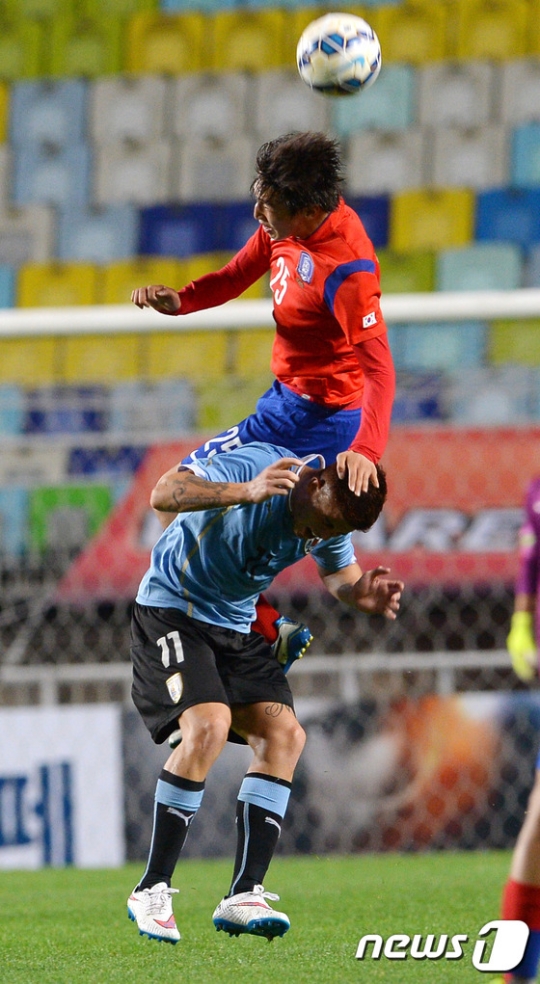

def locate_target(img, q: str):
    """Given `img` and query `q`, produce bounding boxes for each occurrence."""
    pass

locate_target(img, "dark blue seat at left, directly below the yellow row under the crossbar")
[24,385,107,434]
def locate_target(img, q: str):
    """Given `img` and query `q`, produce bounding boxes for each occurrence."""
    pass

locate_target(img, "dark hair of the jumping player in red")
[251,132,344,215]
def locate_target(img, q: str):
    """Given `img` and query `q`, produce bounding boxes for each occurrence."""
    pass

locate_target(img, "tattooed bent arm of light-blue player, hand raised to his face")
[150,458,302,514]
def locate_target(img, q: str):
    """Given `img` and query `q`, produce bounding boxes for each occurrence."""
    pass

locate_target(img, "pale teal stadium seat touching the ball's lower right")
[330,64,417,138]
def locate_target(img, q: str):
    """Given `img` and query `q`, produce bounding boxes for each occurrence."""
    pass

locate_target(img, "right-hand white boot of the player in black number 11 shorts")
[212,885,291,942]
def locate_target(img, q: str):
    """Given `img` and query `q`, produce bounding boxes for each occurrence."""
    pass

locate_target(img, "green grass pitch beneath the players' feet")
[0,852,509,984]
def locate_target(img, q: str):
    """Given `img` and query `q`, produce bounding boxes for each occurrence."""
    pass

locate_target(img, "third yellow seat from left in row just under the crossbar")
[145,325,229,382]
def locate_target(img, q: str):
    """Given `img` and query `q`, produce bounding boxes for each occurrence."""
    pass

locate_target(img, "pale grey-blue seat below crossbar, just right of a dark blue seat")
[109,379,196,440]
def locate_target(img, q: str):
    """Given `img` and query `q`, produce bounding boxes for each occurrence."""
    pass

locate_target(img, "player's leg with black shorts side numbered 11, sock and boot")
[128,605,231,943]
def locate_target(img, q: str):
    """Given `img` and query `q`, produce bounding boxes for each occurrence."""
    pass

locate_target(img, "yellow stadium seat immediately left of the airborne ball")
[209,8,288,72]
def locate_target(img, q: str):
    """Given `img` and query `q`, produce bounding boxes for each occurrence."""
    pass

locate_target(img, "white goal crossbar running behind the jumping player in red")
[0,288,540,339]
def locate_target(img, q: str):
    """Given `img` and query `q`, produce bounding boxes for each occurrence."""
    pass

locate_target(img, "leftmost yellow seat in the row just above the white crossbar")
[17,262,99,307]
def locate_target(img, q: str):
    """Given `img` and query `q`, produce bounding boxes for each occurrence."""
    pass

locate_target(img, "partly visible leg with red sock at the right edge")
[502,763,540,984]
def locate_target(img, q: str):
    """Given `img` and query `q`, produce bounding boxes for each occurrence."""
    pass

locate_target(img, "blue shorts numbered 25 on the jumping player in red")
[184,380,361,465]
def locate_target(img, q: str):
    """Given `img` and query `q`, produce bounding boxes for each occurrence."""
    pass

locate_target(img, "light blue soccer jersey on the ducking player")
[137,444,355,632]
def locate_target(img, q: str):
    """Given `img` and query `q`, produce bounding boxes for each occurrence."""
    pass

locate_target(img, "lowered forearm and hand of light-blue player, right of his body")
[319,563,405,619]
